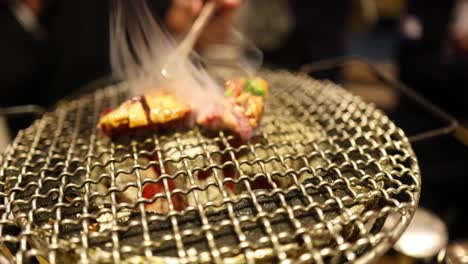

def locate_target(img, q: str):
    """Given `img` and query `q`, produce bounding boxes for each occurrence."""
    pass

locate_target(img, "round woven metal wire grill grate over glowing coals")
[0,72,420,263]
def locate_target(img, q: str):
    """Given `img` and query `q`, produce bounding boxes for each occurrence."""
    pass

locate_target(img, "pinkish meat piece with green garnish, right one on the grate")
[197,78,268,141]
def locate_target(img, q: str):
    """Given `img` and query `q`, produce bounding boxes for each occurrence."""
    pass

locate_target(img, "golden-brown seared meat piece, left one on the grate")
[98,91,192,136]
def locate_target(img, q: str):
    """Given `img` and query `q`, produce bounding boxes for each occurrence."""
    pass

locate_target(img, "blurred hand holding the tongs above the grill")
[165,0,242,47]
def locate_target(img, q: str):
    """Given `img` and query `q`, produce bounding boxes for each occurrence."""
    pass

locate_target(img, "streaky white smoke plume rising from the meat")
[110,0,223,116]
